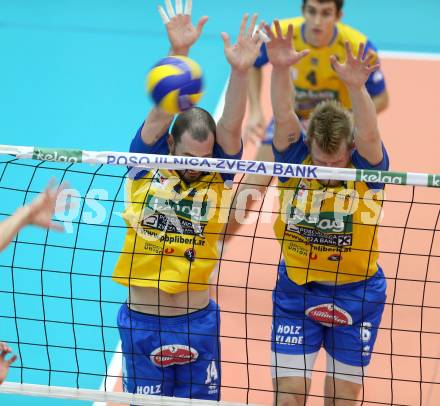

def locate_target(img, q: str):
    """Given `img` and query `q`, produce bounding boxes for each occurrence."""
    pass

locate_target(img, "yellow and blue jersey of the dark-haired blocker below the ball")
[113,125,241,293]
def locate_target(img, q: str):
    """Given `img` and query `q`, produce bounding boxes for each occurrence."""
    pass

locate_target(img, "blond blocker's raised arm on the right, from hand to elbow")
[331,42,383,165]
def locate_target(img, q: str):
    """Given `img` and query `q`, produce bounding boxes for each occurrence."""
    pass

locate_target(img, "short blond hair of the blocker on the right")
[307,100,354,154]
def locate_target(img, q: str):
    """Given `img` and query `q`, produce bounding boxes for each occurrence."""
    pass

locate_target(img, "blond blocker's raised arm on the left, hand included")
[265,20,309,151]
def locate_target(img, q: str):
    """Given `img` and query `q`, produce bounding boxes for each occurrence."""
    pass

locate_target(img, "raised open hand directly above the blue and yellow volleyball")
[157,0,208,55]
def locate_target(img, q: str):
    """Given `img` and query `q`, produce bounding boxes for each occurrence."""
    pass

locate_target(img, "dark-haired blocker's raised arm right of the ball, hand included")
[217,14,262,155]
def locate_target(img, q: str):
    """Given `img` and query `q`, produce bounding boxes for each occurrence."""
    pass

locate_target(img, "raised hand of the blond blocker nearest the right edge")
[330,41,380,87]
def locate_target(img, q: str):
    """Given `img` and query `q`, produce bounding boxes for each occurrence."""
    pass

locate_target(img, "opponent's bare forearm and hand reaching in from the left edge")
[0,180,65,251]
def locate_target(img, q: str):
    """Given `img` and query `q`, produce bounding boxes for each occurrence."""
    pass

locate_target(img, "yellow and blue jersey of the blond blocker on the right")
[274,137,389,285]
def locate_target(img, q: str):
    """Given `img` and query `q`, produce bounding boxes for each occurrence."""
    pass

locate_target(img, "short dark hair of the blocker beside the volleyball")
[171,107,216,144]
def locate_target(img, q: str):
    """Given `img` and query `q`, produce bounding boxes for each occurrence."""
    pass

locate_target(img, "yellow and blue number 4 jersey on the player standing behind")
[255,17,385,119]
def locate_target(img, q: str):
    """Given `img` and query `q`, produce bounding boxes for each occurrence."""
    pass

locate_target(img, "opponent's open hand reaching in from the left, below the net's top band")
[26,182,67,231]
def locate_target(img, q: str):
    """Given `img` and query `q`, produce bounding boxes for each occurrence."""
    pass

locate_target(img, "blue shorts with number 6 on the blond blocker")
[272,261,386,366]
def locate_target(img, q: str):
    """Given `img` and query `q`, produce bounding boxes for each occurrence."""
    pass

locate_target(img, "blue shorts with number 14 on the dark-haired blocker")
[118,301,221,400]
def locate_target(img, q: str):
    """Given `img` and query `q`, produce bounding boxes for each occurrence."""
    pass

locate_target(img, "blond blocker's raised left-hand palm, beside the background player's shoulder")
[264,20,309,67]
